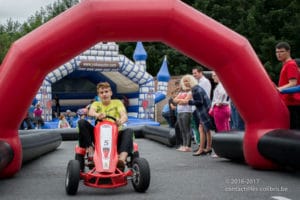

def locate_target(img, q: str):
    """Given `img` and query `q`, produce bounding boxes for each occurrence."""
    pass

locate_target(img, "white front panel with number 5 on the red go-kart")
[100,125,112,169]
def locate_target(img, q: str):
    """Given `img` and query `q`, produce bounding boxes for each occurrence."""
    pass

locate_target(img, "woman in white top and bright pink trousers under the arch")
[209,71,230,132]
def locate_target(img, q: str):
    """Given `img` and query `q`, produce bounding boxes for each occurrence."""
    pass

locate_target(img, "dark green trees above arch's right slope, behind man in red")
[188,0,300,83]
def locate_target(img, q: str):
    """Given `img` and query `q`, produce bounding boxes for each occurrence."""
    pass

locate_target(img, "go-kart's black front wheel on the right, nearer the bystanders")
[132,158,150,192]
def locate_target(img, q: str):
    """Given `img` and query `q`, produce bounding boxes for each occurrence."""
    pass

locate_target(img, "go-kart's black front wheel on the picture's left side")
[65,160,80,195]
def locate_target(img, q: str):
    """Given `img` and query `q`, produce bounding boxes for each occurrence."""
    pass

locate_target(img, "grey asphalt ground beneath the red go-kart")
[0,139,300,200]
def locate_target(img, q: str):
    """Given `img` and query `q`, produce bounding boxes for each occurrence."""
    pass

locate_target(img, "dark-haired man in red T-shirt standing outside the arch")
[275,42,300,129]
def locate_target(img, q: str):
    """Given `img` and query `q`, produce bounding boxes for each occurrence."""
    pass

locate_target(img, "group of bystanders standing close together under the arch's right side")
[163,66,234,156]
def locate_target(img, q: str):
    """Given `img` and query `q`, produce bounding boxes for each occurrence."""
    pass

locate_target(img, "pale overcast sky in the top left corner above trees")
[0,0,57,24]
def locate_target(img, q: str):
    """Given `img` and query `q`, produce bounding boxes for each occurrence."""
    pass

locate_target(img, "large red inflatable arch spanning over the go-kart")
[0,0,289,177]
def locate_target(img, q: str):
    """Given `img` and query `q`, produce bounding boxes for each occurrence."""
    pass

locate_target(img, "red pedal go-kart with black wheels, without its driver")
[65,116,150,195]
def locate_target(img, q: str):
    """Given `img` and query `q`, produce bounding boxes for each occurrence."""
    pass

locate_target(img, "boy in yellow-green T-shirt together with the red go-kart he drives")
[65,82,150,194]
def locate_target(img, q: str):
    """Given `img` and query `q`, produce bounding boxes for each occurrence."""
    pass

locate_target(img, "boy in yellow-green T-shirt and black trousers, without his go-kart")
[78,82,133,168]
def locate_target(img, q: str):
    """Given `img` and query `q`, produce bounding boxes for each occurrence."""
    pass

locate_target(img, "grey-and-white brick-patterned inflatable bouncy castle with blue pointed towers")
[36,42,170,121]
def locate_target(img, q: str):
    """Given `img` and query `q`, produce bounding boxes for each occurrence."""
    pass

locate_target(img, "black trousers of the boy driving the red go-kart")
[78,119,133,154]
